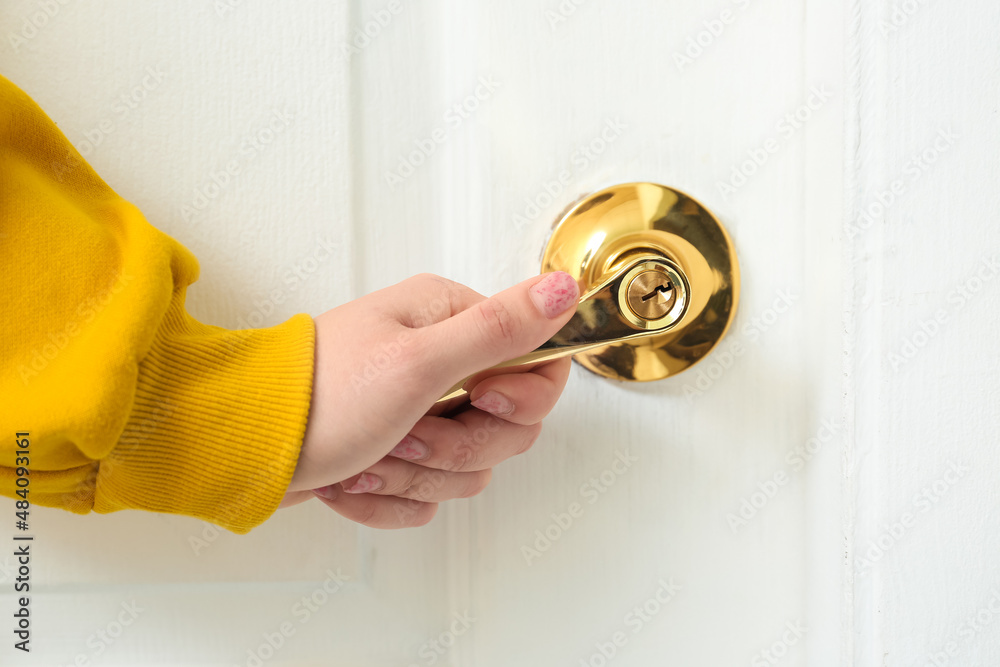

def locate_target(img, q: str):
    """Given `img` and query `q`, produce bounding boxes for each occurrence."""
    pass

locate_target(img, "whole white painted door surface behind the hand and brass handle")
[0,0,1000,667]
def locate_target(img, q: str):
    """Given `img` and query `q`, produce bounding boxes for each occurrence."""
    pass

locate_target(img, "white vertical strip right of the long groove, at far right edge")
[844,2,1000,666]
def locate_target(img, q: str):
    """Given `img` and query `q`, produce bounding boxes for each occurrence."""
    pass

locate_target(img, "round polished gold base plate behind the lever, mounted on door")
[542,183,740,382]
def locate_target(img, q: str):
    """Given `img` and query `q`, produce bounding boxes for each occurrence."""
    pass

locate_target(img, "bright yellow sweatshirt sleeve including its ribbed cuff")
[0,77,315,533]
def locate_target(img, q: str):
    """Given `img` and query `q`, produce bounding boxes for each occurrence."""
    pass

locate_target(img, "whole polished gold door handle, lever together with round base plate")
[438,183,740,403]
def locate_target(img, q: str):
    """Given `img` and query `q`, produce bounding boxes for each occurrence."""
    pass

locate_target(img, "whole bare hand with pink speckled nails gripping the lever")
[282,272,579,528]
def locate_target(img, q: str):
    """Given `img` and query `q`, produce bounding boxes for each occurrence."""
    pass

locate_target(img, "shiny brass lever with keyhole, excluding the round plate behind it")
[437,254,691,403]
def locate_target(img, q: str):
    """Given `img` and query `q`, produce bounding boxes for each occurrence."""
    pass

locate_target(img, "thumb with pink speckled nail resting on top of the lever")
[421,271,580,384]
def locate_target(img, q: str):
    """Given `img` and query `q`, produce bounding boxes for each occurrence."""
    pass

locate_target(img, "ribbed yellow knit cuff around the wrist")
[94,294,315,533]
